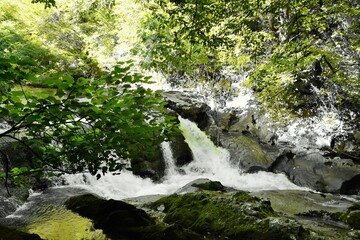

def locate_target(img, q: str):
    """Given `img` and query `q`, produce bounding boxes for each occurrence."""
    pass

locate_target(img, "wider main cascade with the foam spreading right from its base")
[174,117,300,191]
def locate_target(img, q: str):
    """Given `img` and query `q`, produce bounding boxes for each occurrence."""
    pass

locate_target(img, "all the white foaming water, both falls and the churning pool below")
[61,118,304,199]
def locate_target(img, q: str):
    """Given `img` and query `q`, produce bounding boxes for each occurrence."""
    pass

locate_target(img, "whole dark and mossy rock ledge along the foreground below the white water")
[60,179,360,240]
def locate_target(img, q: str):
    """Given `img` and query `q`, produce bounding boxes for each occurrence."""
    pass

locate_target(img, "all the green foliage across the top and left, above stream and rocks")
[0,0,360,191]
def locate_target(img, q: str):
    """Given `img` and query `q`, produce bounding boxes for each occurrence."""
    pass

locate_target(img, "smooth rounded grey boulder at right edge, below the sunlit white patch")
[270,151,360,193]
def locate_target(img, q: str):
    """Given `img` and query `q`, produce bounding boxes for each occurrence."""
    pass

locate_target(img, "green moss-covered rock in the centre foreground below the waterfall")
[150,191,309,239]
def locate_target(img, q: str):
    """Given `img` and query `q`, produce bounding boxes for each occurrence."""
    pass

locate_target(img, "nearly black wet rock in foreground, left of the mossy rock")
[65,194,201,240]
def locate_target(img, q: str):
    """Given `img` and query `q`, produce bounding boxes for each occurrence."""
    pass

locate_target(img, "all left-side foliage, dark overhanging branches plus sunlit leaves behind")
[0,0,176,191]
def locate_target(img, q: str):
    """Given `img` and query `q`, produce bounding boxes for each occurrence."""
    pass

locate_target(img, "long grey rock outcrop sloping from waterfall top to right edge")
[163,91,360,194]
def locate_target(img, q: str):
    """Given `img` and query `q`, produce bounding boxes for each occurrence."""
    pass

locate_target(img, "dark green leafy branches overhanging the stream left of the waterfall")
[0,56,175,188]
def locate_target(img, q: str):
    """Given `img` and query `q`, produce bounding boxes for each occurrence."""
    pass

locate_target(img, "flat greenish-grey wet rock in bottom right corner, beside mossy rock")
[251,190,360,240]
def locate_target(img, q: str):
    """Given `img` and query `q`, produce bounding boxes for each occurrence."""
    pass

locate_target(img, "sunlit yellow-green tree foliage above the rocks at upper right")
[135,0,360,119]
